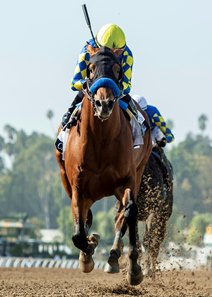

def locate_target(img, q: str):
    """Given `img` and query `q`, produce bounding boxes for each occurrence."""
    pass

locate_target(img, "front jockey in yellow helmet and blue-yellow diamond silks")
[62,24,137,127]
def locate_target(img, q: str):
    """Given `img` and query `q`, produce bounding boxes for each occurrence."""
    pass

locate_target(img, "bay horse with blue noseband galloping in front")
[56,44,152,285]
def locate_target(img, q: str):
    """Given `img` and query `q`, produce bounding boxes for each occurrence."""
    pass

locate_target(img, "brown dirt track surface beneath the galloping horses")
[0,268,212,297]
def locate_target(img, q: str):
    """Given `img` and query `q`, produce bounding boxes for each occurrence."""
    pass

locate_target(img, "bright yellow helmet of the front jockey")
[96,24,126,49]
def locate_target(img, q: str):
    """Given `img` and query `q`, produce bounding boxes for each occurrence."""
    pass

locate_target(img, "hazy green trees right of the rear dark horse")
[169,134,212,218]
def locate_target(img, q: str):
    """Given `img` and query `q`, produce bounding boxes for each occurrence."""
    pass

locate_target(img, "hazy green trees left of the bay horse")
[0,126,61,228]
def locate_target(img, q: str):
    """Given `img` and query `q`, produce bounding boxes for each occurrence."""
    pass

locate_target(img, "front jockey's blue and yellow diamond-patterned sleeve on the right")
[121,46,133,95]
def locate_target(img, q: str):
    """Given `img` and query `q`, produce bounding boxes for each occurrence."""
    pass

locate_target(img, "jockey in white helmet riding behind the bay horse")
[132,95,174,147]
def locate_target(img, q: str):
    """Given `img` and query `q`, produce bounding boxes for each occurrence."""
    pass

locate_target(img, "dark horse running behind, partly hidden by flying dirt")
[137,146,173,277]
